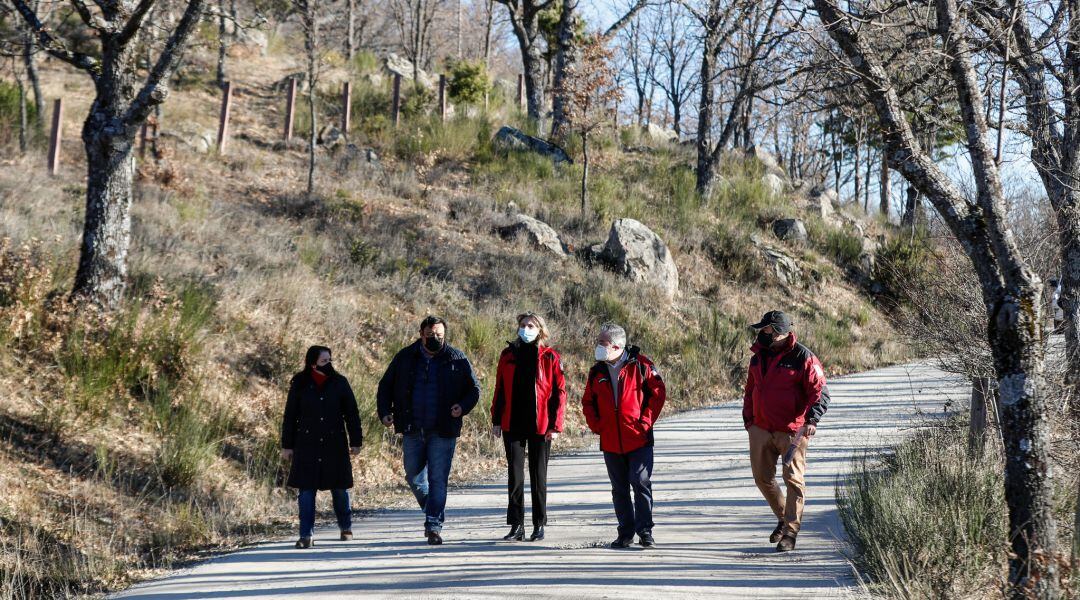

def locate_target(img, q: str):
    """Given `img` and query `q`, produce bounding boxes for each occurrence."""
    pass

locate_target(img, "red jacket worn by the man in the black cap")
[743,333,828,434]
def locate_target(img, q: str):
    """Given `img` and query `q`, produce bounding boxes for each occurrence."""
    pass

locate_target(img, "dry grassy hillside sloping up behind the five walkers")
[0,50,908,597]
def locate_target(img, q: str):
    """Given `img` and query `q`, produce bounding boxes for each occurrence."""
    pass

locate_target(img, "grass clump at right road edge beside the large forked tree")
[837,423,1008,599]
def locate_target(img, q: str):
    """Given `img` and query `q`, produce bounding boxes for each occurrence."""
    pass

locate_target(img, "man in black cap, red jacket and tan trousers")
[743,311,828,553]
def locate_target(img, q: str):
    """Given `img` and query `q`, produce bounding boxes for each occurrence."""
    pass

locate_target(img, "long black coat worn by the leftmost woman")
[281,372,364,490]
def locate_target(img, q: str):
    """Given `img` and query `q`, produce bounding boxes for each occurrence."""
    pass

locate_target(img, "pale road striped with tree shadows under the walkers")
[119,365,968,600]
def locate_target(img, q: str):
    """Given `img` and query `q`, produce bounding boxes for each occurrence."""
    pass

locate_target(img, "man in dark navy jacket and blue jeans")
[377,316,480,545]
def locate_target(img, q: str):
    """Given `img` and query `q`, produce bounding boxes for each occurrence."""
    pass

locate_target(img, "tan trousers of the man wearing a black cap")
[750,425,810,535]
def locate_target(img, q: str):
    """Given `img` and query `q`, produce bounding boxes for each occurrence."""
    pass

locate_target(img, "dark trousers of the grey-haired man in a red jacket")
[604,446,652,537]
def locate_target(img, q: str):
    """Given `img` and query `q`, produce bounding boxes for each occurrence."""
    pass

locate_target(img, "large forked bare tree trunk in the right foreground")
[813,0,1059,599]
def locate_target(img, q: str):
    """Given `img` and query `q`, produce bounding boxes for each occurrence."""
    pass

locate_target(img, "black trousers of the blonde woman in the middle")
[502,432,551,527]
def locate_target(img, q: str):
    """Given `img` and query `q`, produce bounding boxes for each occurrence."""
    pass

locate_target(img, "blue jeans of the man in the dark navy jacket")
[402,432,458,533]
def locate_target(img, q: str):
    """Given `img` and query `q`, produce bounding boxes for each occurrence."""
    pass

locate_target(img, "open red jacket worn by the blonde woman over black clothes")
[491,345,566,435]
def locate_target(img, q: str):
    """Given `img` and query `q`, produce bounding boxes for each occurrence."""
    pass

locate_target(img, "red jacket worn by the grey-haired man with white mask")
[581,346,667,454]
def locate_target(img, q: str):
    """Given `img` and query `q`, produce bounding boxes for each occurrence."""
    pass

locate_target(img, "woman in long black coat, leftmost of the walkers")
[281,345,364,548]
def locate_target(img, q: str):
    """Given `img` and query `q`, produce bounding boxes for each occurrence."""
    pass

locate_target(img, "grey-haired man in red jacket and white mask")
[581,323,667,548]
